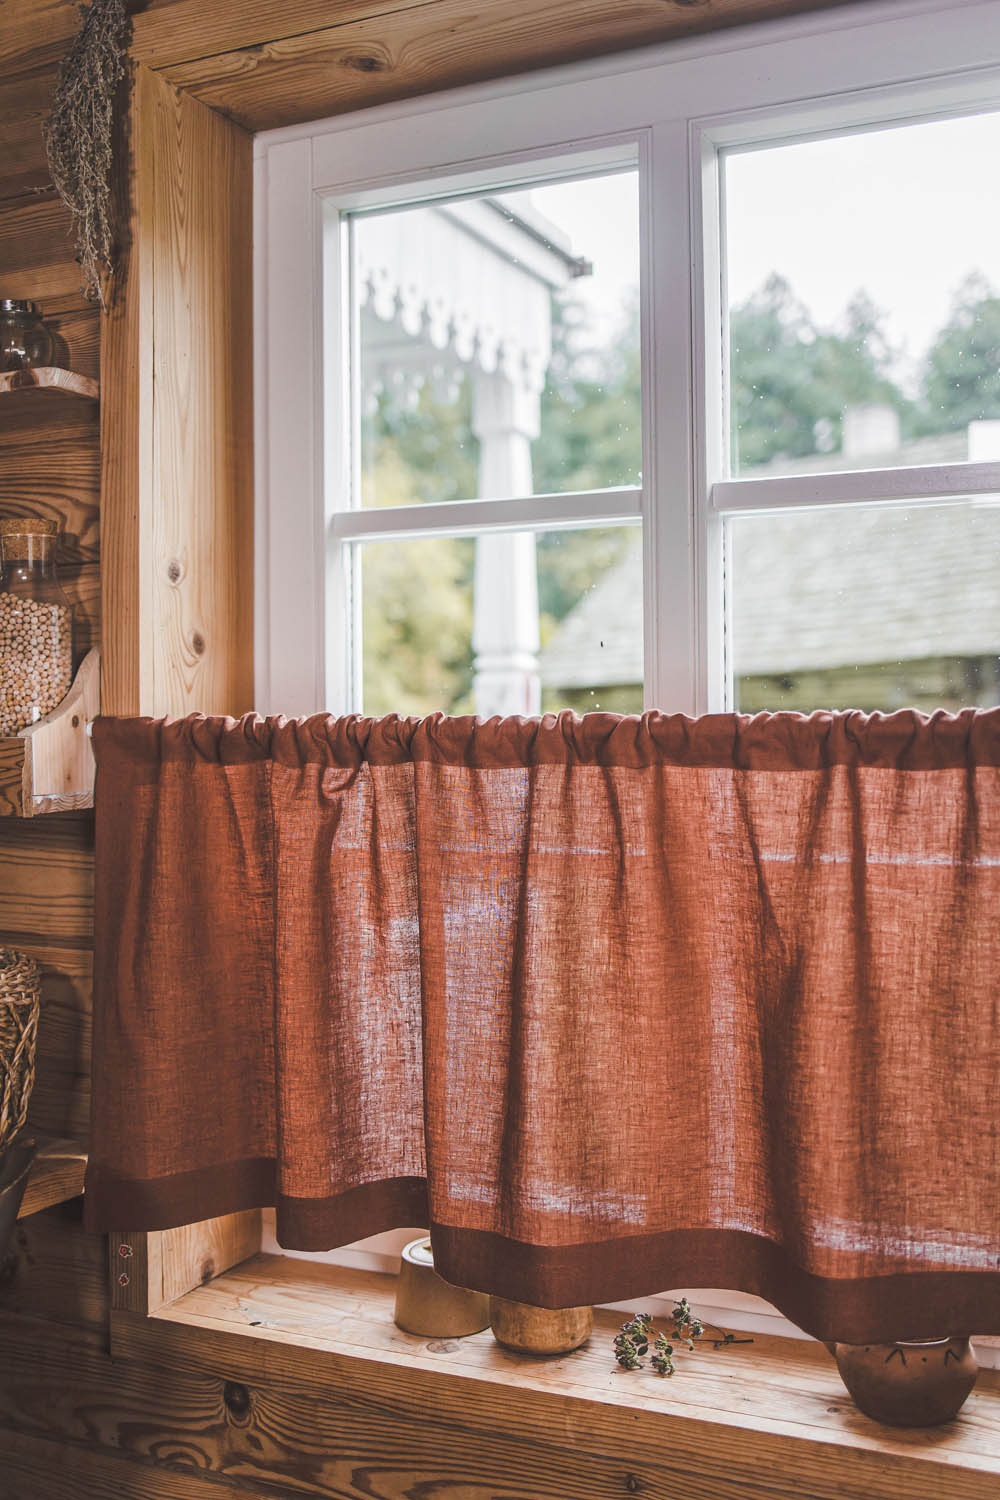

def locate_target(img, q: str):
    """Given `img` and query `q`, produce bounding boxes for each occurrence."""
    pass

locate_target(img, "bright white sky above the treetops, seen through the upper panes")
[511,113,1000,386]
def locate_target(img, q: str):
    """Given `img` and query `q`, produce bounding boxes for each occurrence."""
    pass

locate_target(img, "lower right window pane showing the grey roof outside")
[726,498,1000,714]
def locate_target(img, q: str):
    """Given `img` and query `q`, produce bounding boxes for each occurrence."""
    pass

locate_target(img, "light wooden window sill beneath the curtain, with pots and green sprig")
[111,1256,1000,1500]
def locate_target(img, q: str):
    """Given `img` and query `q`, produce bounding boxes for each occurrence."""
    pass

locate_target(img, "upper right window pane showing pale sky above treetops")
[724,114,1000,474]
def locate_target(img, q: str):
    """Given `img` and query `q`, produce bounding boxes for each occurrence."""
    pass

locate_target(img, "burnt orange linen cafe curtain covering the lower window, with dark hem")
[85,710,1000,1341]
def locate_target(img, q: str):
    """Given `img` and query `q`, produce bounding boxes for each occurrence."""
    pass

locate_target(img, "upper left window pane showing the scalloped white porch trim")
[351,171,642,506]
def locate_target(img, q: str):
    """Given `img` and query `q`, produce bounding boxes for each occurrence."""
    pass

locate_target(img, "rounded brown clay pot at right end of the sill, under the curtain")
[826,1338,979,1427]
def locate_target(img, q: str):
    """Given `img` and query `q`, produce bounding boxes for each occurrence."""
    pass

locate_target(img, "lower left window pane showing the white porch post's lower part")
[358,527,642,717]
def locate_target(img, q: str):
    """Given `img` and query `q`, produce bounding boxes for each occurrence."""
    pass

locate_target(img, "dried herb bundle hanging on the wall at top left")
[45,0,132,308]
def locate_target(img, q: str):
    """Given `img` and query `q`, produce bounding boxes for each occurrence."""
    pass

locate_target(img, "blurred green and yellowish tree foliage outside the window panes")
[363,276,1000,713]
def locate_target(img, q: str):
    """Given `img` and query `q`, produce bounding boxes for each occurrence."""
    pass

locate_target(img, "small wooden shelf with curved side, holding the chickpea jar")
[0,651,100,818]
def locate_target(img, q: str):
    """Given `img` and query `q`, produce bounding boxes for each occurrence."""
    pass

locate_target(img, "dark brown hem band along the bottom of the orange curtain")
[84,1161,1000,1343]
